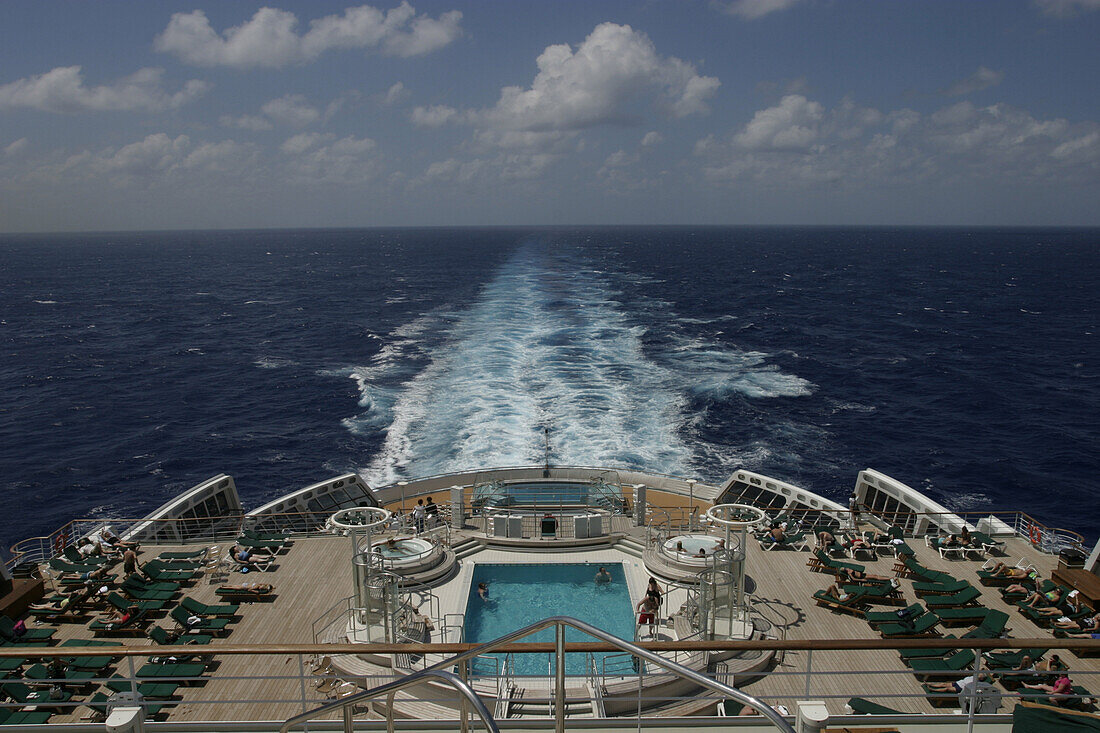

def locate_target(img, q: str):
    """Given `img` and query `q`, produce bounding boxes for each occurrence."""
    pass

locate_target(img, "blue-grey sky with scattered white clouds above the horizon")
[0,0,1100,232]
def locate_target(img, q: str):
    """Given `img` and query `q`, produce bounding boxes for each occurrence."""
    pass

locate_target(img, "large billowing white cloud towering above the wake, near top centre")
[480,23,719,131]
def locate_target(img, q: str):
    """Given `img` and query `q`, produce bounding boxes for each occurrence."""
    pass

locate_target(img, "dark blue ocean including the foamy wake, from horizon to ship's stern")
[0,228,1100,547]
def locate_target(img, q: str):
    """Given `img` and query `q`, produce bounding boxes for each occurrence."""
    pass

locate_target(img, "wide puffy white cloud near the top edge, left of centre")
[154,2,462,68]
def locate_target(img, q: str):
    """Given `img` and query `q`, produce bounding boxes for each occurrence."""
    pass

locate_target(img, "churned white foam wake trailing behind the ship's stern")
[344,245,812,485]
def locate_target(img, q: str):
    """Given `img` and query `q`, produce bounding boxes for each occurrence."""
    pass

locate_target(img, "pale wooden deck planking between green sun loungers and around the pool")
[25,521,1100,722]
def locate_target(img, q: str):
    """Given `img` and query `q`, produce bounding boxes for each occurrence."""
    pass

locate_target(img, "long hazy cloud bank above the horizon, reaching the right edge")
[695,96,1100,187]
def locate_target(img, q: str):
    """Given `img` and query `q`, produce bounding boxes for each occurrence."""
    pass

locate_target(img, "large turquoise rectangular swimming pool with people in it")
[465,562,634,676]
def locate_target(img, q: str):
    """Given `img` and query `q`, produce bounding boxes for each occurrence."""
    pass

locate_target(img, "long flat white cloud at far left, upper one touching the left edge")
[0,66,210,112]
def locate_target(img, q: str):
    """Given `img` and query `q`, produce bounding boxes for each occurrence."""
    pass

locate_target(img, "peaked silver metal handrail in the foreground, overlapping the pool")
[297,616,794,733]
